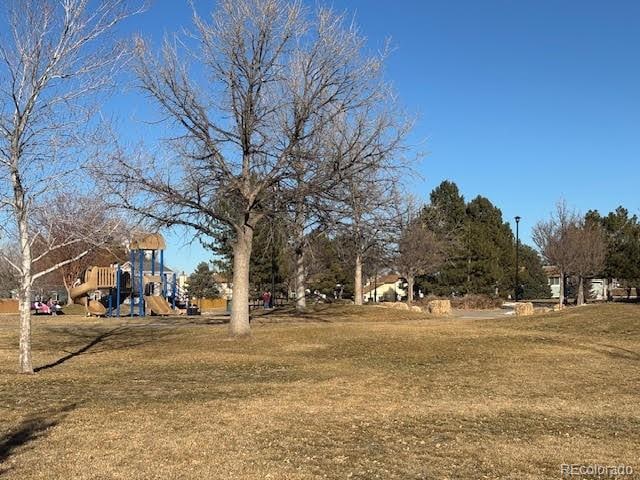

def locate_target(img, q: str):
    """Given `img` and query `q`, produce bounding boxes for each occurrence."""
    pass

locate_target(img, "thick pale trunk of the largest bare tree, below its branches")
[229,225,253,337]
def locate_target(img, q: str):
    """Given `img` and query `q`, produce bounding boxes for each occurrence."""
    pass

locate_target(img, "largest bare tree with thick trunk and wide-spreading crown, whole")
[102,0,408,335]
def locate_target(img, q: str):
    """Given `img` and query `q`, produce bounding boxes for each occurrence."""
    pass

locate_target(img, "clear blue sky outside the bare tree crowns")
[115,0,640,271]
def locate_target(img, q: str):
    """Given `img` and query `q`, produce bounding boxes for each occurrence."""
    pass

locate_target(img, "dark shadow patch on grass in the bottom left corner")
[0,403,78,476]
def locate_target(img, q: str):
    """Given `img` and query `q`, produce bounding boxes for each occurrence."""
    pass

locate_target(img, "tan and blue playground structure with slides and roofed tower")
[69,233,177,317]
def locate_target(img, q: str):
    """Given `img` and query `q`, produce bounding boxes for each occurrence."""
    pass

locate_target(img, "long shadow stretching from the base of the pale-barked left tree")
[34,326,169,372]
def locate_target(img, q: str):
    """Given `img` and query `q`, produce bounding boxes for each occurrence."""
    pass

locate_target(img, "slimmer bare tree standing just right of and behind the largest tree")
[285,10,390,310]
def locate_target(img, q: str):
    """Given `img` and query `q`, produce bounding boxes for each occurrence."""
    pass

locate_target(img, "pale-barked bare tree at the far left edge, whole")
[0,0,140,373]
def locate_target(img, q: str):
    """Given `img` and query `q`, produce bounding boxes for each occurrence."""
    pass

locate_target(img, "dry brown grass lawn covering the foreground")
[0,305,640,480]
